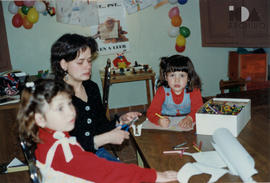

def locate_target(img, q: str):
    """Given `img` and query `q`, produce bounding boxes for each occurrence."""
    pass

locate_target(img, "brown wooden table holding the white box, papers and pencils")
[131,89,270,182]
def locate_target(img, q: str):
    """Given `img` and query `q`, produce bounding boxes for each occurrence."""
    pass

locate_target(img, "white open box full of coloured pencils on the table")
[196,98,251,137]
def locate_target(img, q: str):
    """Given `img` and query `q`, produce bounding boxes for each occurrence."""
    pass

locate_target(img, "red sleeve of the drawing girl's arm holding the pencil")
[146,87,165,125]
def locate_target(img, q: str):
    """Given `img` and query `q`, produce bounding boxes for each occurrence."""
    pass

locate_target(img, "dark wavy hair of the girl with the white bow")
[17,79,74,142]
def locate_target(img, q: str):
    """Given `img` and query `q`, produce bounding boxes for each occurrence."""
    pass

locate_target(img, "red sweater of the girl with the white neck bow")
[35,129,157,183]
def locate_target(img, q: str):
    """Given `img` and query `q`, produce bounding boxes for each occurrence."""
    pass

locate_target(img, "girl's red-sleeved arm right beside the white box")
[189,89,203,123]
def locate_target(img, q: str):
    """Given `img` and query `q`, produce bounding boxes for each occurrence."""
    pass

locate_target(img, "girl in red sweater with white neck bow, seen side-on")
[17,79,177,183]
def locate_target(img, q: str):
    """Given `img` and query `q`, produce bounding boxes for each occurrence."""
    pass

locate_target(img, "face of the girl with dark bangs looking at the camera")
[166,71,188,95]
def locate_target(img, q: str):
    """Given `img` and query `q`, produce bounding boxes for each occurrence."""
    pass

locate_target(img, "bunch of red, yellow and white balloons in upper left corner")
[8,0,46,29]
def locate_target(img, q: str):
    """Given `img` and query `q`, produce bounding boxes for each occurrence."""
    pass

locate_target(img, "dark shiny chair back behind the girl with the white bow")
[20,136,41,183]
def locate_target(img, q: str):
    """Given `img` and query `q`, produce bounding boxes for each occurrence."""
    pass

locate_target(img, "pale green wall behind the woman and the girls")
[2,0,249,108]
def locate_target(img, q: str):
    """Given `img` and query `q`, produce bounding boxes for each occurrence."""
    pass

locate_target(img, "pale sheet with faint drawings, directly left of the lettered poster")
[55,0,99,26]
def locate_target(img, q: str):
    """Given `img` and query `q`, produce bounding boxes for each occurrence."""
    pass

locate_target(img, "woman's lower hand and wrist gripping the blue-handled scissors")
[94,126,129,147]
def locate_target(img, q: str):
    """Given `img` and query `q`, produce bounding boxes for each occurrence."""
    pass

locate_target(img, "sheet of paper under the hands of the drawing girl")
[142,116,193,132]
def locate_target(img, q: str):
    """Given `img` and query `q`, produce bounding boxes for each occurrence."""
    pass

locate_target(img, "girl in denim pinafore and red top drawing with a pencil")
[147,55,203,129]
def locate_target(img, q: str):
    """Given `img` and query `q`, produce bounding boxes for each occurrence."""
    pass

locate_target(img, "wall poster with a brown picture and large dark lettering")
[90,0,129,55]
